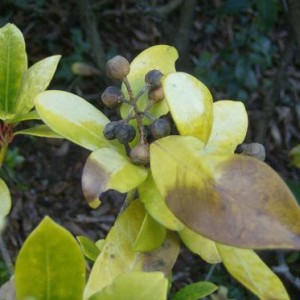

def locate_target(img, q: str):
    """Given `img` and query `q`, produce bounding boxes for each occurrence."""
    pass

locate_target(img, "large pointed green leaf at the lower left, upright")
[15,217,85,300]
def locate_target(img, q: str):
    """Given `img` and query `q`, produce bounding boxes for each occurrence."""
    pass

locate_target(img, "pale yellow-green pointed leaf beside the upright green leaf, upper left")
[14,55,61,115]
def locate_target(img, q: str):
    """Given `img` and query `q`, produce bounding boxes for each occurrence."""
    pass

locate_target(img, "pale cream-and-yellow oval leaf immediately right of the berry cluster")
[163,72,213,143]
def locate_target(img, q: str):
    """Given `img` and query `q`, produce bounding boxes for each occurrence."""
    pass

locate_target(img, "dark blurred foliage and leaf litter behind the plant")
[0,0,300,299]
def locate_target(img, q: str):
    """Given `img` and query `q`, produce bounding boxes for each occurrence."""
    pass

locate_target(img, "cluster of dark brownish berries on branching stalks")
[101,55,171,165]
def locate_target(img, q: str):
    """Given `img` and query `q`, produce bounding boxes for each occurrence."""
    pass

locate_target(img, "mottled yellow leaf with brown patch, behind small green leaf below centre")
[84,200,179,299]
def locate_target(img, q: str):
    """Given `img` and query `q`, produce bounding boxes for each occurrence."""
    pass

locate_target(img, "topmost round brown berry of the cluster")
[106,55,130,80]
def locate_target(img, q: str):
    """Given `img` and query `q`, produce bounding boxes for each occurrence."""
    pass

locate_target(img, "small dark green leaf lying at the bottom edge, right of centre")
[170,281,218,300]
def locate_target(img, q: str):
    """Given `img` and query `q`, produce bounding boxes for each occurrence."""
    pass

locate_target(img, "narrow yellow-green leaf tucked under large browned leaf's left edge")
[138,172,184,230]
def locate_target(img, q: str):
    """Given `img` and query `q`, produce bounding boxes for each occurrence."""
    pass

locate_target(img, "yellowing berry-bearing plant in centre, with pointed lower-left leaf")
[1,22,300,300]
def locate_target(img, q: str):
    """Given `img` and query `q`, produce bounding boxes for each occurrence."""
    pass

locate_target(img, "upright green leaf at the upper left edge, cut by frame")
[0,24,27,120]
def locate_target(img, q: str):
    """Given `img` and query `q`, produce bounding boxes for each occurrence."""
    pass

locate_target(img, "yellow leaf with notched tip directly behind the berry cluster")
[121,45,178,122]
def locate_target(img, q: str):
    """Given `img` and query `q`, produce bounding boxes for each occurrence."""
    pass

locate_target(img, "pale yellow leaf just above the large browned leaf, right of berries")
[205,100,248,154]
